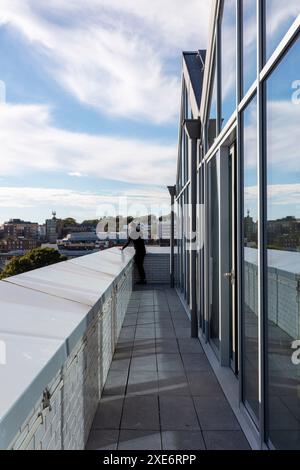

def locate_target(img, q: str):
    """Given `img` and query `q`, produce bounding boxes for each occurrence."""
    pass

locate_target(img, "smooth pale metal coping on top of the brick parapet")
[0,250,132,448]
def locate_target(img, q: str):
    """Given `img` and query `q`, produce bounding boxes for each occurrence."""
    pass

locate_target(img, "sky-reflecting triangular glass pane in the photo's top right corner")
[266,0,300,60]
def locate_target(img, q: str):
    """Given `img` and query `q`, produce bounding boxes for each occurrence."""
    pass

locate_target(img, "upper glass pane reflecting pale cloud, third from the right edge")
[221,0,236,128]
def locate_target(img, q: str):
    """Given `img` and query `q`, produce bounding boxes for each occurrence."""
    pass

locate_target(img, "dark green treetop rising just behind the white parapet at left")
[0,248,67,279]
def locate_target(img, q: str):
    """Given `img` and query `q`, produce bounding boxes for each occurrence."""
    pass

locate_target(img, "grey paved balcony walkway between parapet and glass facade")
[87,285,249,450]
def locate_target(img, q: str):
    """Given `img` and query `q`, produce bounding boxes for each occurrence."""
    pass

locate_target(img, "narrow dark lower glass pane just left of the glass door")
[209,157,220,349]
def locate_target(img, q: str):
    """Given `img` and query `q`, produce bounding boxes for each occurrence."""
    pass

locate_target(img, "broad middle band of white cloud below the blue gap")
[0,104,176,185]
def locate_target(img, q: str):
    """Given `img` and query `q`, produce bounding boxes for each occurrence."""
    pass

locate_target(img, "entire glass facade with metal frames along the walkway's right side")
[177,0,300,450]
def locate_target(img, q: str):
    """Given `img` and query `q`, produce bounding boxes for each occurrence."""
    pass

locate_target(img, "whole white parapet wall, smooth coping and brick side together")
[0,249,133,449]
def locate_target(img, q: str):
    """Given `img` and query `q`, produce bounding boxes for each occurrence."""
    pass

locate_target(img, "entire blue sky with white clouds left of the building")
[0,0,210,223]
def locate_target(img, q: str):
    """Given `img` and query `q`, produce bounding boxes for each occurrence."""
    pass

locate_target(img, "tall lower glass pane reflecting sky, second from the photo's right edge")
[243,97,259,421]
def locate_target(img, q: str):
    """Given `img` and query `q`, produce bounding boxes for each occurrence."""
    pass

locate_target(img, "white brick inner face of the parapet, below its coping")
[9,263,133,450]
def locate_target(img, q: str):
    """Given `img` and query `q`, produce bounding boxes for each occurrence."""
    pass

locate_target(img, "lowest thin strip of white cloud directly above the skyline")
[0,187,170,224]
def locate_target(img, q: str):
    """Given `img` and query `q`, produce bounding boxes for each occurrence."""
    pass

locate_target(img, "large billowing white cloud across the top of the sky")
[0,0,211,123]
